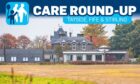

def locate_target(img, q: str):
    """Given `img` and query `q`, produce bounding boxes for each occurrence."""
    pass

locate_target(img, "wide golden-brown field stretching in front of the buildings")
[0,64,140,84]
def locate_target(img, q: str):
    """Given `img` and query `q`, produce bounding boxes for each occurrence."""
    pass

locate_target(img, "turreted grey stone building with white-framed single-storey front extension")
[51,27,128,62]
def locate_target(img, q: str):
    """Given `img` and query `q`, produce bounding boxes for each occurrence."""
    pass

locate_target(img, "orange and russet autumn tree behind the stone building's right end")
[83,24,108,47]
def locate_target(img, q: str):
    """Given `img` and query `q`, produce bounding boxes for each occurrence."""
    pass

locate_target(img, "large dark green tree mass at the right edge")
[110,20,140,57]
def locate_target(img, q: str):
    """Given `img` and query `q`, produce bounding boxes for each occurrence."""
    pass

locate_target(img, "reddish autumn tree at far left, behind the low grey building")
[1,33,17,48]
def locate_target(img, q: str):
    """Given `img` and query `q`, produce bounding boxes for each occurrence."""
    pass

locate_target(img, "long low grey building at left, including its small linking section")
[0,49,57,63]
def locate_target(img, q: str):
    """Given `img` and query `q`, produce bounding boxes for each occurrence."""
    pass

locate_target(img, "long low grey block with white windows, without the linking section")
[0,49,44,62]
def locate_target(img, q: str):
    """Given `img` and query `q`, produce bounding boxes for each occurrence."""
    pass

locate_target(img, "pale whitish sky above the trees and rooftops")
[0,16,137,40]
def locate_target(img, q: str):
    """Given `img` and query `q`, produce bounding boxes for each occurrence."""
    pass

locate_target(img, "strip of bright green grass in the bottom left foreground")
[0,72,95,84]
